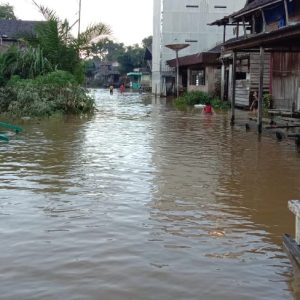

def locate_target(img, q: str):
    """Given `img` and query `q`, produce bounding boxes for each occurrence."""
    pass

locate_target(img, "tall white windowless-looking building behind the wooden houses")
[152,0,246,96]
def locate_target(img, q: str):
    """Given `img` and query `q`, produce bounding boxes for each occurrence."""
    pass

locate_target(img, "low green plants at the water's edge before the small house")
[175,91,229,109]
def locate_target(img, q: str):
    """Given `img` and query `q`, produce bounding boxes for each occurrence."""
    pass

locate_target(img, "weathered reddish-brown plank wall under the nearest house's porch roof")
[271,52,300,110]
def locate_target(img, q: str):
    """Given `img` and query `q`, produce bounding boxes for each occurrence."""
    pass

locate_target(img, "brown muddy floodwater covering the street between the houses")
[0,90,300,300]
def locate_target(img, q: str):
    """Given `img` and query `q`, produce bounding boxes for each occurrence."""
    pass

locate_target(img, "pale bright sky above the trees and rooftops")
[5,0,153,46]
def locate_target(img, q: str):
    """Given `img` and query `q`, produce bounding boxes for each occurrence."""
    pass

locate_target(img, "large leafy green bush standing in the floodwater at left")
[0,71,94,117]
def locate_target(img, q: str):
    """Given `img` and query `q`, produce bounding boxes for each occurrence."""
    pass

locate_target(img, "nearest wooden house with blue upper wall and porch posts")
[214,0,300,127]
